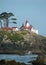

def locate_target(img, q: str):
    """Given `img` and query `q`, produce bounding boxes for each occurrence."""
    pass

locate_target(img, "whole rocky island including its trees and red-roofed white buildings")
[0,12,46,54]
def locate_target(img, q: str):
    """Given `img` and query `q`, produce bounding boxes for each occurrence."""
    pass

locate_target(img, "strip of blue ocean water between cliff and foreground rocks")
[0,54,38,64]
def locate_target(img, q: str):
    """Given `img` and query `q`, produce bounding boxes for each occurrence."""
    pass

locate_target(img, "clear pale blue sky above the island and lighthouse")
[0,0,46,36]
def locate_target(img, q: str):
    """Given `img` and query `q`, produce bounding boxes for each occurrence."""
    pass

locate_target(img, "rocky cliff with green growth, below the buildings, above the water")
[0,31,46,54]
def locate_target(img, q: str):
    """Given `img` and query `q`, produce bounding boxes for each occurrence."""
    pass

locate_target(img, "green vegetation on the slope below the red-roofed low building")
[0,31,23,42]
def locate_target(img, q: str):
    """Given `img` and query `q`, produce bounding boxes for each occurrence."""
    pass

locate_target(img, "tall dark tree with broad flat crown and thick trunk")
[0,12,14,27]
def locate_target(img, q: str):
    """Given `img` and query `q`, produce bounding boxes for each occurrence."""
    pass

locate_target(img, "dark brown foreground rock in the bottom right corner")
[32,55,46,65]
